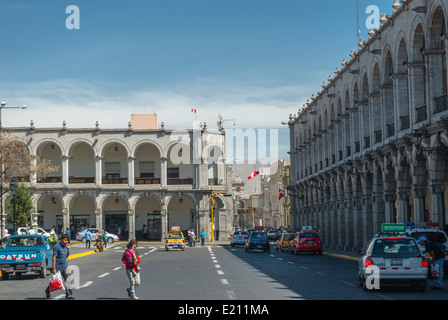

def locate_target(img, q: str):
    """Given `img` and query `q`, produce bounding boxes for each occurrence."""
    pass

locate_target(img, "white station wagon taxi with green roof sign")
[358,224,428,291]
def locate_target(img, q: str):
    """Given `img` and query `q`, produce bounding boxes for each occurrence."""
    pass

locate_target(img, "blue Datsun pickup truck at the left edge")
[0,234,53,280]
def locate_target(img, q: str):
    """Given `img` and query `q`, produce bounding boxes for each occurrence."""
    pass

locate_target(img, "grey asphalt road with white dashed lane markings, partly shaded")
[0,243,448,302]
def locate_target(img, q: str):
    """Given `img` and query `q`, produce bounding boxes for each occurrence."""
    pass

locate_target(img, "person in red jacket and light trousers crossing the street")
[121,239,140,300]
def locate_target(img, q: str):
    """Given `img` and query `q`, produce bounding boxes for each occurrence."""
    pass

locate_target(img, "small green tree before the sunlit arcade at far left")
[7,182,33,228]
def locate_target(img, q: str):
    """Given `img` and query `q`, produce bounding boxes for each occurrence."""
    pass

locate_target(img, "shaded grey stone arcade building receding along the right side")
[288,0,448,250]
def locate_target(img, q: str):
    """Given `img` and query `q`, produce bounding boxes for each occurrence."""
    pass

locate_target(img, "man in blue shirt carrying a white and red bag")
[45,234,74,299]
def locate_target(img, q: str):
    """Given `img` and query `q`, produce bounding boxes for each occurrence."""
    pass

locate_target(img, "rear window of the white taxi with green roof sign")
[372,239,421,259]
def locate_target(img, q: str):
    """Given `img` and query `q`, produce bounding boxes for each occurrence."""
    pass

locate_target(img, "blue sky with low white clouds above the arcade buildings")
[0,0,393,159]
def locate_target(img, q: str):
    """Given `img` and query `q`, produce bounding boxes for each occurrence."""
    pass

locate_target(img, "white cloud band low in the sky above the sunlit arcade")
[0,79,312,129]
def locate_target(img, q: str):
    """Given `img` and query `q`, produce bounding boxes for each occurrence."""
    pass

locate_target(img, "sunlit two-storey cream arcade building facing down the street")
[3,122,233,240]
